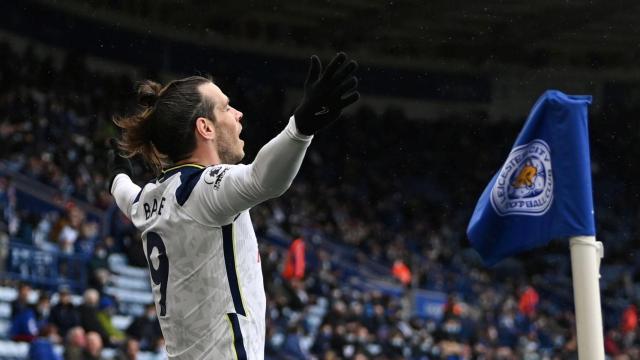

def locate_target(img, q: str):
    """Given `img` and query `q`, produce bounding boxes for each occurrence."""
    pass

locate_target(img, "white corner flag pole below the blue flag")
[569,236,604,360]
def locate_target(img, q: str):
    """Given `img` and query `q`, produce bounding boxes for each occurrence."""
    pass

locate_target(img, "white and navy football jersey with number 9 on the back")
[112,117,312,360]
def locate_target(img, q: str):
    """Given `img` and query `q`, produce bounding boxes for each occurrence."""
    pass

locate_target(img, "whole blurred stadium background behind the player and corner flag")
[0,0,640,360]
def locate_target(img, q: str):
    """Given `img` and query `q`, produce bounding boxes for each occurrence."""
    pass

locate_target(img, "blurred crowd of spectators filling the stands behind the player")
[0,40,640,360]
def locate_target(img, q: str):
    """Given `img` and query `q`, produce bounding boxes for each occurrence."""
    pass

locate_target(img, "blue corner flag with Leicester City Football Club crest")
[467,90,595,265]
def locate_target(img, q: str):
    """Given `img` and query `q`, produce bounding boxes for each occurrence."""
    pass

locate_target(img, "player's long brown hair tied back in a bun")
[113,76,215,173]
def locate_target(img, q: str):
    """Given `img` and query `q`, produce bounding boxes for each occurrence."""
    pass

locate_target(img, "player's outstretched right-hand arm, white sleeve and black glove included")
[196,53,360,223]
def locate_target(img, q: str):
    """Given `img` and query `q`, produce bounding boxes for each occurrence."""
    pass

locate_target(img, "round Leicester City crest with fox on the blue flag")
[491,139,553,216]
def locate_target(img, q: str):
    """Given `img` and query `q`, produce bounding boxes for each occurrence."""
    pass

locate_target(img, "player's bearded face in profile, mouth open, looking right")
[200,83,244,164]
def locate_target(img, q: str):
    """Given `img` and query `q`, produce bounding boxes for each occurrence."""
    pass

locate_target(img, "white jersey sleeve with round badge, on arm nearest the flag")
[189,117,313,225]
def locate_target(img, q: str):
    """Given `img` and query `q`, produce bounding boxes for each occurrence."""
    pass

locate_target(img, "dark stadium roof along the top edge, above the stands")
[47,0,640,68]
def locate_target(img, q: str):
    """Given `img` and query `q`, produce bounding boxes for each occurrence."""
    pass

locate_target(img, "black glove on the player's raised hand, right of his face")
[294,52,360,135]
